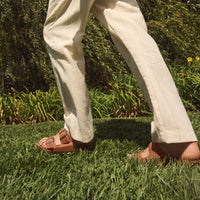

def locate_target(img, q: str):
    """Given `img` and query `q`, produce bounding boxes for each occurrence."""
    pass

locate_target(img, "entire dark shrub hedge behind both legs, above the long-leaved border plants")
[0,0,200,93]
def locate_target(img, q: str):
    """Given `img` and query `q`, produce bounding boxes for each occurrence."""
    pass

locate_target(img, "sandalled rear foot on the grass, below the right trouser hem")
[128,142,200,162]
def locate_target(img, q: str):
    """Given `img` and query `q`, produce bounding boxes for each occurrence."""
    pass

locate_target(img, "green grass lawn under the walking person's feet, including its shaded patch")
[0,113,200,200]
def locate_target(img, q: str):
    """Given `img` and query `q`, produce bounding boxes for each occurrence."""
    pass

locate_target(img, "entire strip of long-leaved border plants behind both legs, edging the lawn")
[0,57,200,124]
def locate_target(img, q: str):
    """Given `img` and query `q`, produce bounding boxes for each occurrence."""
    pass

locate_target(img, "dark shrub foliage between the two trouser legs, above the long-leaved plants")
[83,15,128,90]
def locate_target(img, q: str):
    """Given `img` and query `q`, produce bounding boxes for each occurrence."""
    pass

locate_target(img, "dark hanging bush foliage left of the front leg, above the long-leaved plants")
[0,0,53,93]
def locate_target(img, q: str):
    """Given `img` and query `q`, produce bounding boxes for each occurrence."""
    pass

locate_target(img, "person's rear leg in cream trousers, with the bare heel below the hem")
[91,0,199,158]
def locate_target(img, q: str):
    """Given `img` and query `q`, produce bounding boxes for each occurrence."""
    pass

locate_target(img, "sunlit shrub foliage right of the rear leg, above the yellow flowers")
[139,0,200,64]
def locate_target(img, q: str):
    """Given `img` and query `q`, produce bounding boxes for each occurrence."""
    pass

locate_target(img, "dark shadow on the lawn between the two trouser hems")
[94,118,151,146]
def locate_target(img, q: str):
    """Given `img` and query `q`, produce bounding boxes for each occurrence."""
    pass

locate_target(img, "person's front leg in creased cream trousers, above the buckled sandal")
[39,0,94,152]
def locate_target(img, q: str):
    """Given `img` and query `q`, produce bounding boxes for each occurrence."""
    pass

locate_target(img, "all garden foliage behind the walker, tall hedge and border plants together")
[0,0,200,124]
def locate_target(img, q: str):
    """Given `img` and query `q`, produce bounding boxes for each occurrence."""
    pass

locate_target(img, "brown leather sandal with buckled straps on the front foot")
[36,128,95,154]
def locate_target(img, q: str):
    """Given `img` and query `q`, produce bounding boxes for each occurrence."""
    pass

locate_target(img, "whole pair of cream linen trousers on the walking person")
[44,0,197,143]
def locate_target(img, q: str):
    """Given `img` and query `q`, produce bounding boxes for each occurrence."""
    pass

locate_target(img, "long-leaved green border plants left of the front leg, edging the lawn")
[0,87,63,124]
